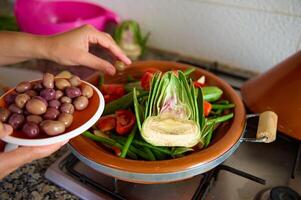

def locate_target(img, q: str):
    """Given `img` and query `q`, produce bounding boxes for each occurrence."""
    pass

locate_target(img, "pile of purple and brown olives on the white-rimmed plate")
[0,73,93,138]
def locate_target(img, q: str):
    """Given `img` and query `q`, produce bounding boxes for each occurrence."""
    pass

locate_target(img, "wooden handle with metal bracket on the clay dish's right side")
[242,111,278,143]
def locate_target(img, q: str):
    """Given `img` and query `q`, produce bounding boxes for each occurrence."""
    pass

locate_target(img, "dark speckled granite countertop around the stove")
[0,49,255,200]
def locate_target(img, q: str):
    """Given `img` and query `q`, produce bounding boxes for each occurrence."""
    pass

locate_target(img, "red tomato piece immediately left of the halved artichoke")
[116,110,136,135]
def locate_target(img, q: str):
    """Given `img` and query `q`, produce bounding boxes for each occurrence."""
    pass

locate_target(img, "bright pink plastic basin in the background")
[14,0,120,35]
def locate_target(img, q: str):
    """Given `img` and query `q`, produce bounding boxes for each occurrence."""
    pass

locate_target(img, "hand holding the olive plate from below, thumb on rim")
[0,122,68,179]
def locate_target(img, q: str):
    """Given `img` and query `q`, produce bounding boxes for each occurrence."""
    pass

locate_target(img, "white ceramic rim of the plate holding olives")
[1,81,105,146]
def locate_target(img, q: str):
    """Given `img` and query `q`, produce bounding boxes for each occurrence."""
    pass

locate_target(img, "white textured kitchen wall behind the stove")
[94,0,301,72]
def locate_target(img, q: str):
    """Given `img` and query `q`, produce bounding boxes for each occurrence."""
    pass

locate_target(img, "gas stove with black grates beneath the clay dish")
[45,60,301,200]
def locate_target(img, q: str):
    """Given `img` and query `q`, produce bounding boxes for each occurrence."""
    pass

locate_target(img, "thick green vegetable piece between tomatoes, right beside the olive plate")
[103,92,133,115]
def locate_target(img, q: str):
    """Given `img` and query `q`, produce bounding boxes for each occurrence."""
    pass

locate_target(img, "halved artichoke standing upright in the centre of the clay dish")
[141,71,203,147]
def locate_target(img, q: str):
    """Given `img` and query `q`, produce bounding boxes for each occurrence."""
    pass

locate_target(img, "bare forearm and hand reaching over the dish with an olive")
[0,25,131,75]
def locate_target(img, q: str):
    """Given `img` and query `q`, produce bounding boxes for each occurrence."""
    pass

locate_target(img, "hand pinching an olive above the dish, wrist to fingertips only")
[46,25,131,75]
